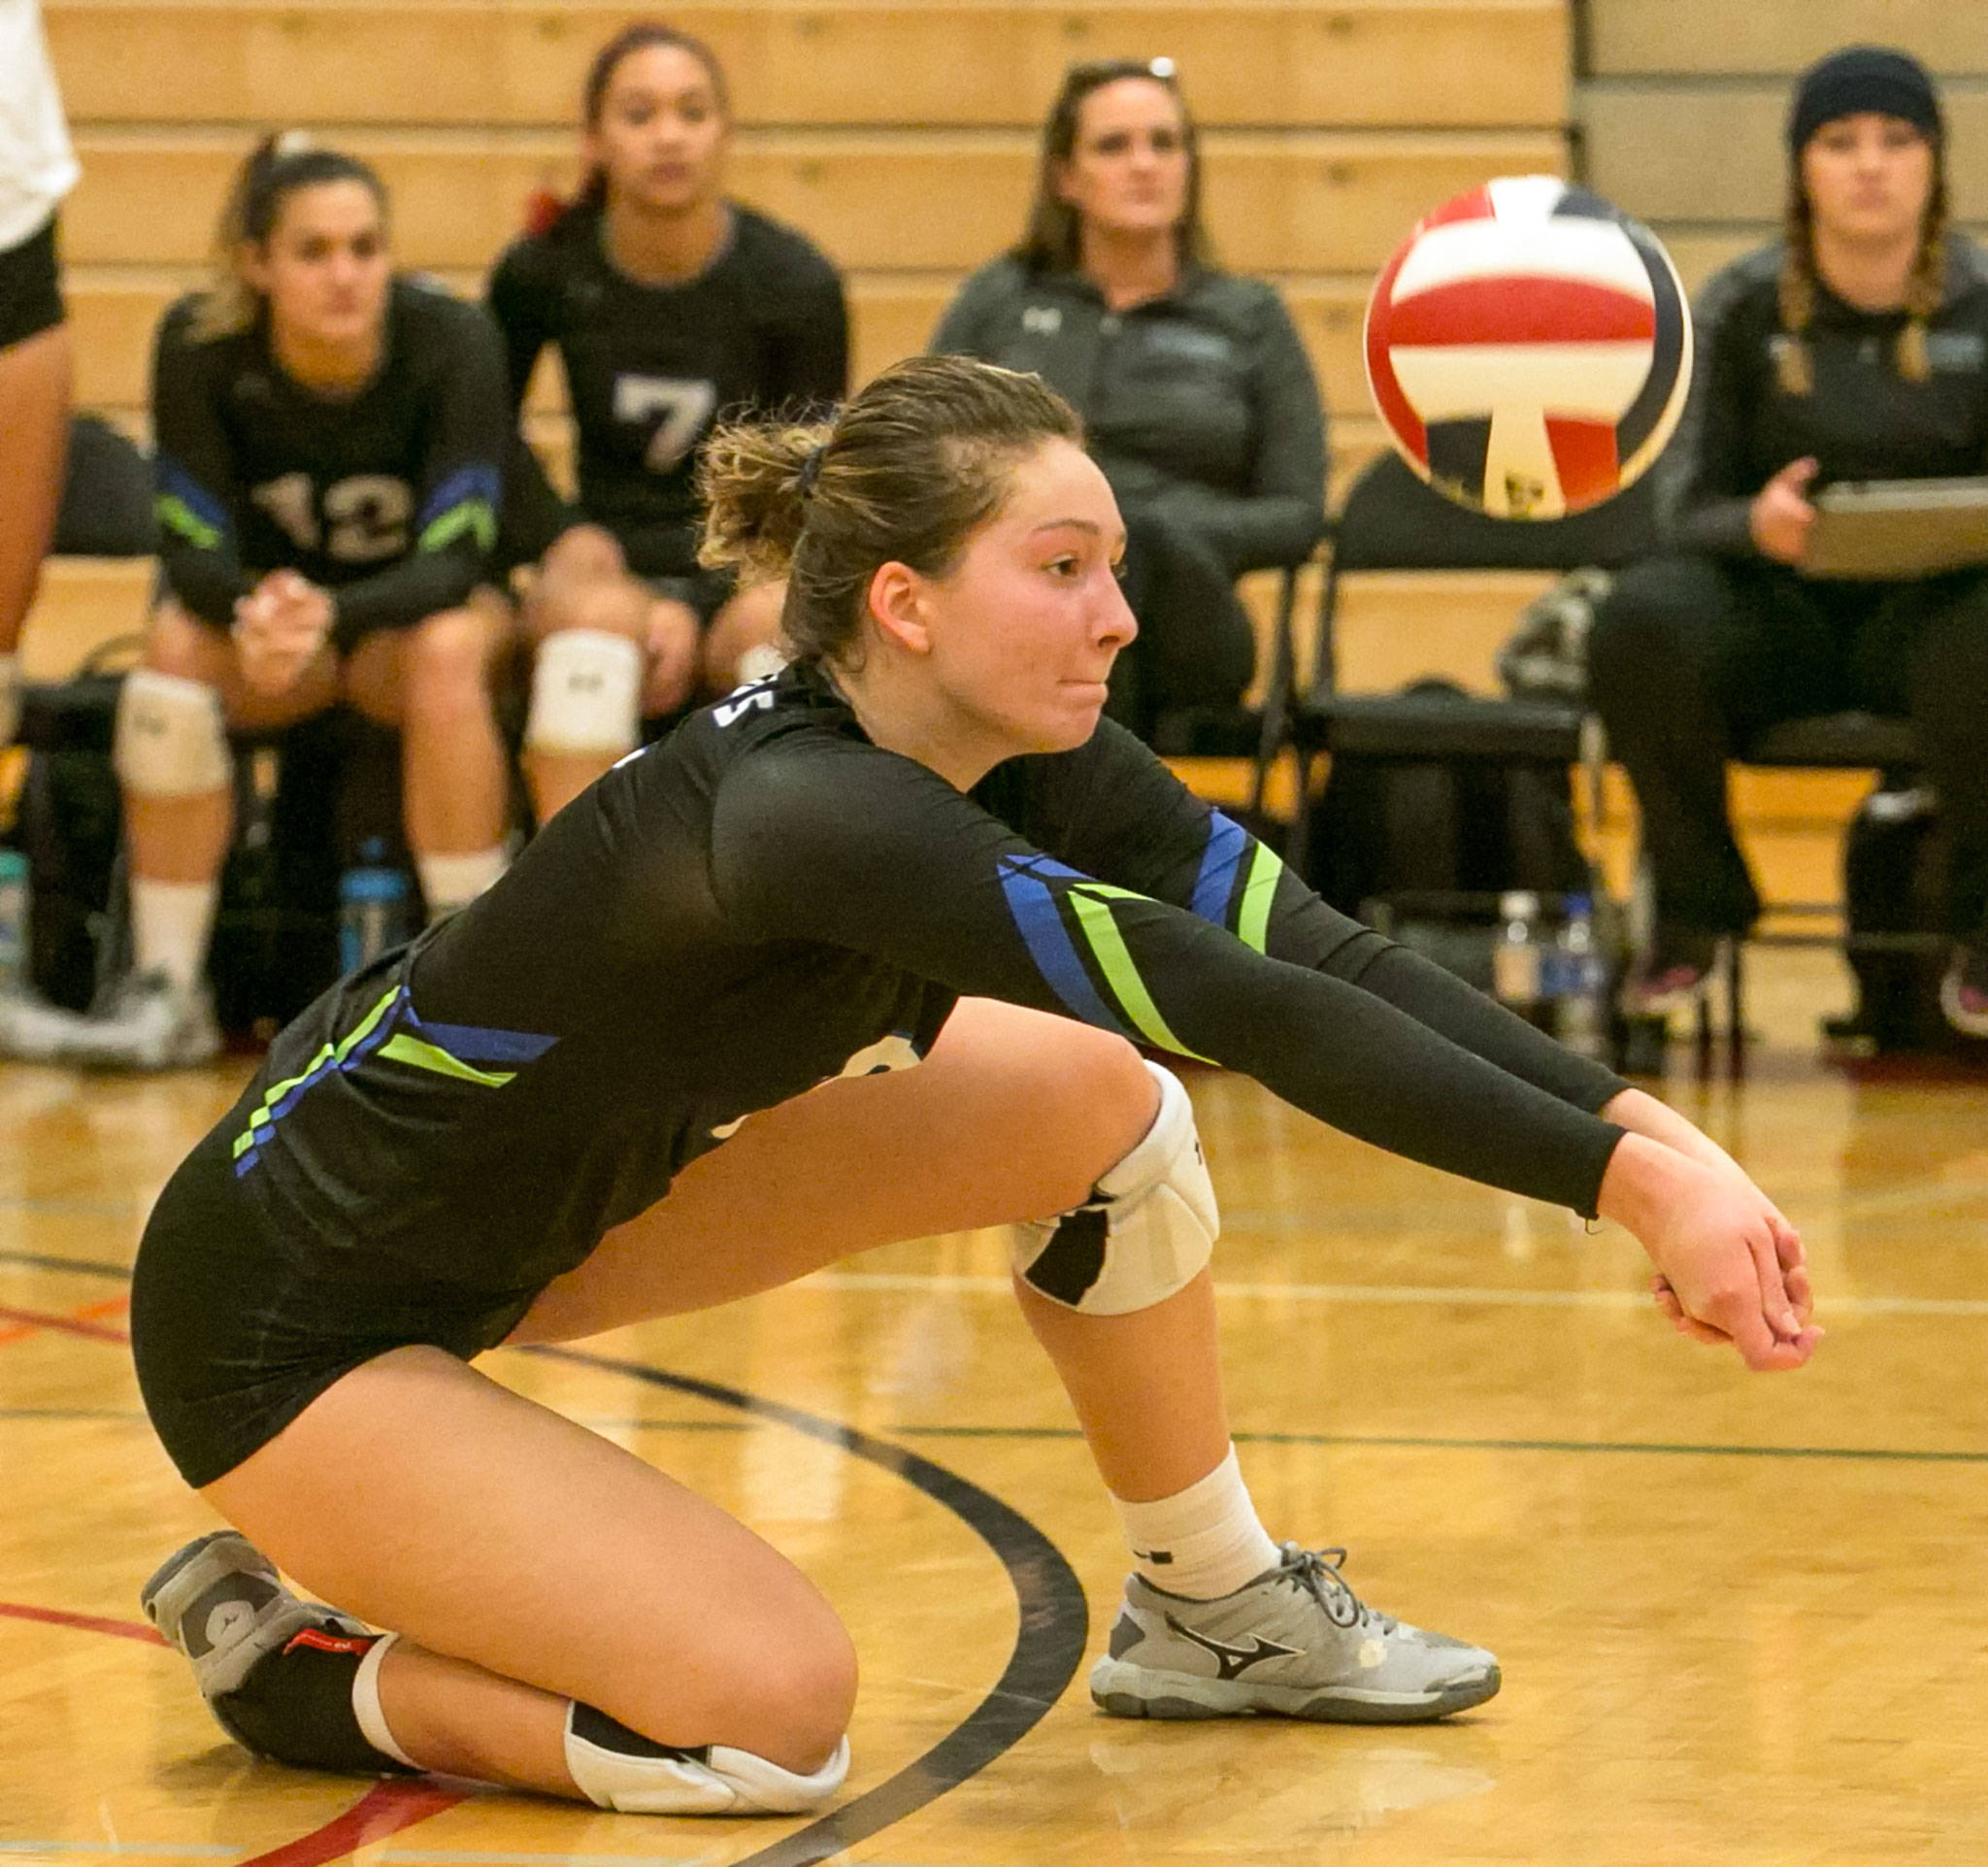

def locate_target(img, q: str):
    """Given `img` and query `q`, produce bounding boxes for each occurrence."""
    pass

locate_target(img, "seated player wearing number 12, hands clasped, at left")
[8,137,509,1068]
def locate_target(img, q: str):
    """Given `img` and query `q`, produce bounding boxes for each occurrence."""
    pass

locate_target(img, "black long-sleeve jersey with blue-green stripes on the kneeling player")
[222,666,1622,1296]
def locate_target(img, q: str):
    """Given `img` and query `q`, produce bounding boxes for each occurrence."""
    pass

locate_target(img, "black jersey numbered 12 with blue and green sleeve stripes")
[151,279,509,650]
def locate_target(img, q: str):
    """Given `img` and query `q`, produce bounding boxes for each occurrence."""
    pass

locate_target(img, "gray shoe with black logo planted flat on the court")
[1091,1543,1499,1724]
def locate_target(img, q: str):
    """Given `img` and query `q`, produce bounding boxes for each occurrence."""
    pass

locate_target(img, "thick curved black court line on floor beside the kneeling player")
[521,1348,1089,1867]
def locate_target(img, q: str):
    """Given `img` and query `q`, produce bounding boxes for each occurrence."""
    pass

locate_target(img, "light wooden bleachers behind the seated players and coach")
[38,0,1569,682]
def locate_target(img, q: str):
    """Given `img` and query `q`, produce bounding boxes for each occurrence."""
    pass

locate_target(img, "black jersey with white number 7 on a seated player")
[489,205,848,577]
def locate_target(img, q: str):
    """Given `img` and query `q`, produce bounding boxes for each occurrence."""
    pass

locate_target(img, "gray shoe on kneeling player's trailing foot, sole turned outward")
[137,1529,368,1710]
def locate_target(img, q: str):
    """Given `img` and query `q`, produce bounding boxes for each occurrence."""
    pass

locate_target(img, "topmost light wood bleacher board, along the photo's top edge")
[46,0,1569,127]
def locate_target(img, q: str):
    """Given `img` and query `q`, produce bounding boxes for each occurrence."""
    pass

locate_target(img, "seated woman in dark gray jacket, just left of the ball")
[933,59,1326,732]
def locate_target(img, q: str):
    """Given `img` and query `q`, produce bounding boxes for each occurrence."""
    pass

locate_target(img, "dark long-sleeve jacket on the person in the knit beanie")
[1660,235,1988,556]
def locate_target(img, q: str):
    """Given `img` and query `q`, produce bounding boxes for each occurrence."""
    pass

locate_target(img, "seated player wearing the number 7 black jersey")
[489,24,848,821]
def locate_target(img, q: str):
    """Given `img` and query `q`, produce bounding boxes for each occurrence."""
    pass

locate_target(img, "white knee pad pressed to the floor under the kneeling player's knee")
[567,1700,848,1816]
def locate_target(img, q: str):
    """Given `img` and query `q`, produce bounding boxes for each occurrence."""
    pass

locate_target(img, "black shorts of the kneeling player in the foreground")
[131,1121,537,1489]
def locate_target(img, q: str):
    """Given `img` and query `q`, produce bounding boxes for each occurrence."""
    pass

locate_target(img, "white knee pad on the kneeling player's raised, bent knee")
[1008,1064,1223,1317]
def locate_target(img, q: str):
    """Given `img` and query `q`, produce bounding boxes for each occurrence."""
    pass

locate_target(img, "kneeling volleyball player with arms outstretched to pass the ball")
[131,358,1817,1814]
